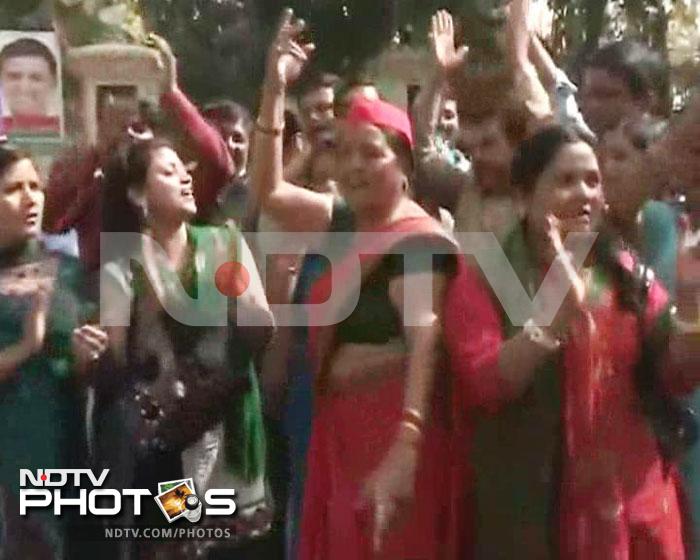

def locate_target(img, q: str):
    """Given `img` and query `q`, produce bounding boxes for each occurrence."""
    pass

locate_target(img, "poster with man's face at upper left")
[0,30,63,137]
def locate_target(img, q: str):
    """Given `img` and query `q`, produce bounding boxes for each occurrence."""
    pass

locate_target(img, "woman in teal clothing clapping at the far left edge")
[0,147,106,558]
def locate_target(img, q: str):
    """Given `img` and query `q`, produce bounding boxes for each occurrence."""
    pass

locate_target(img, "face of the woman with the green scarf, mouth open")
[145,147,197,222]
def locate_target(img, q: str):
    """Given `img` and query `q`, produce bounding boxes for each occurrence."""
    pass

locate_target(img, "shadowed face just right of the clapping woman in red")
[599,125,649,213]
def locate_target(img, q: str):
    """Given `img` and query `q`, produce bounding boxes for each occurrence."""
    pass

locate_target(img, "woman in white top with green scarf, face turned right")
[96,139,273,554]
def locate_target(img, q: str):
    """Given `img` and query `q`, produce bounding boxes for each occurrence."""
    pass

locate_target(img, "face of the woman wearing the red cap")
[337,123,407,217]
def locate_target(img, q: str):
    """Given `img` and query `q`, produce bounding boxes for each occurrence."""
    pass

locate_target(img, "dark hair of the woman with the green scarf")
[102,138,172,233]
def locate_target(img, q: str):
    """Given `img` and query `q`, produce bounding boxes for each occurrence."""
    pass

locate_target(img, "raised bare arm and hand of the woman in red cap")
[250,10,333,232]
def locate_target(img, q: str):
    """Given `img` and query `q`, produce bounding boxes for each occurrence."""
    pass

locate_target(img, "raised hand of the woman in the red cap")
[265,8,315,88]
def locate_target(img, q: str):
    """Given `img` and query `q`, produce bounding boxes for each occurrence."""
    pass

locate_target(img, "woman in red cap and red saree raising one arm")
[252,11,464,560]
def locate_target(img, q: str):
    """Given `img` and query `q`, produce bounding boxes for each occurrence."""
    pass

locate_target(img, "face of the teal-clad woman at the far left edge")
[0,159,44,246]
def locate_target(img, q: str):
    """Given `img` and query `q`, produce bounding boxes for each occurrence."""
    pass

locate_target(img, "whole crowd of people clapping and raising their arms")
[0,0,700,560]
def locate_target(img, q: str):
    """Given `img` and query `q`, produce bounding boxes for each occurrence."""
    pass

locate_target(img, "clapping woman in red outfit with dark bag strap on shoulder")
[445,126,700,560]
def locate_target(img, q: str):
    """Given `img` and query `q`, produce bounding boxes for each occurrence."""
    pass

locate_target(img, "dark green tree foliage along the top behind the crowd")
[46,0,696,106]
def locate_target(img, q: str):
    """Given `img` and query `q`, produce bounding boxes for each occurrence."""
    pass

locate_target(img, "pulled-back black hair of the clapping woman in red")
[511,125,590,194]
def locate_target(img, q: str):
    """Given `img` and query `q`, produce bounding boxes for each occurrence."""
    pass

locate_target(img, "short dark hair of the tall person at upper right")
[583,39,669,104]
